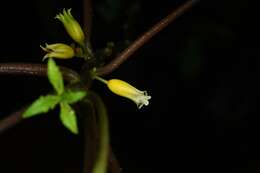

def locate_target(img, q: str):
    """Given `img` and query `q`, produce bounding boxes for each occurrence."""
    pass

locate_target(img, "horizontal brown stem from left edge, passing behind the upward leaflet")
[0,63,80,82]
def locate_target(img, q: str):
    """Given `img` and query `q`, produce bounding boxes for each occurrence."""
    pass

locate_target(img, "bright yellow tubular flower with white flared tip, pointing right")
[106,79,151,109]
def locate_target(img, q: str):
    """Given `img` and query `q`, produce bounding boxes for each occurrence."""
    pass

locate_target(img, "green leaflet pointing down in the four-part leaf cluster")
[60,102,78,134]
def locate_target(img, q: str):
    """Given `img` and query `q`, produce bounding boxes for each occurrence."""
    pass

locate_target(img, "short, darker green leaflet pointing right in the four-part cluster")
[61,90,87,104]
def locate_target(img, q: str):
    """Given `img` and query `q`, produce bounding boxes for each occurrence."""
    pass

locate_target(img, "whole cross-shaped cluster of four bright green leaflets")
[23,58,86,134]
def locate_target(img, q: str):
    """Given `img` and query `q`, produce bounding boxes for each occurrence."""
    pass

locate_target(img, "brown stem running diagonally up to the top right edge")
[97,0,199,76]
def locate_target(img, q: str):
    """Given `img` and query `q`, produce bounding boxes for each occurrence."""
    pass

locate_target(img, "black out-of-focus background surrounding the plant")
[0,0,260,173]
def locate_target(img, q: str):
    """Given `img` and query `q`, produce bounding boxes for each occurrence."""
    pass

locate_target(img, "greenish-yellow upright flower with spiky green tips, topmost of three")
[55,9,85,45]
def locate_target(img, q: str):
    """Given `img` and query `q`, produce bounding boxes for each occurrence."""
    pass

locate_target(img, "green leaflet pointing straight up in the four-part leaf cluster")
[48,58,64,95]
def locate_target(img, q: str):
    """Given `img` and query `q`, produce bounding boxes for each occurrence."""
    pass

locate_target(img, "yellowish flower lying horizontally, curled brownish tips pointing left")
[40,43,74,60]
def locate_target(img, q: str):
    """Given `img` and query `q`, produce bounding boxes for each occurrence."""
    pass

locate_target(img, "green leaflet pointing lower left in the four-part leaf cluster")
[23,95,60,118]
